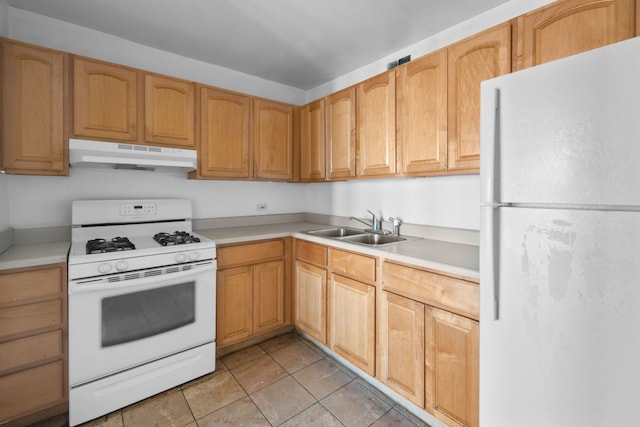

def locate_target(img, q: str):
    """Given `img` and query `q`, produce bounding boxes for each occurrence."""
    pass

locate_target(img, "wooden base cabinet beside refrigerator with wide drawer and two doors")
[377,261,479,426]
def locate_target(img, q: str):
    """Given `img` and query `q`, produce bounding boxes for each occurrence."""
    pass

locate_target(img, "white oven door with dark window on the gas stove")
[69,261,216,387]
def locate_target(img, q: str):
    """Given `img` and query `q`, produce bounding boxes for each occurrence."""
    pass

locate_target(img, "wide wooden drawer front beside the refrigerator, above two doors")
[382,261,480,319]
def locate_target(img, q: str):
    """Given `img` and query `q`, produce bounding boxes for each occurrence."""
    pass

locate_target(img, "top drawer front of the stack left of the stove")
[0,268,62,305]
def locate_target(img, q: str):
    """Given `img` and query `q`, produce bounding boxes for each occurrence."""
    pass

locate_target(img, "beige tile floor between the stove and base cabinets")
[37,333,426,427]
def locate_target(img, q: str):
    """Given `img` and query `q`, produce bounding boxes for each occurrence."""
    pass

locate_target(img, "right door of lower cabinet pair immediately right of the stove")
[253,260,284,335]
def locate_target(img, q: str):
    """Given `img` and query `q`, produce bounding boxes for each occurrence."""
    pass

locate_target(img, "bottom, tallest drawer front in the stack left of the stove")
[0,361,66,424]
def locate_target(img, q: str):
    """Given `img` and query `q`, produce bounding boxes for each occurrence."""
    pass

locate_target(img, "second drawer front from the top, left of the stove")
[0,299,62,339]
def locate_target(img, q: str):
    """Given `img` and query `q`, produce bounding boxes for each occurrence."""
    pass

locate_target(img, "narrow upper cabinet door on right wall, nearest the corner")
[300,99,326,181]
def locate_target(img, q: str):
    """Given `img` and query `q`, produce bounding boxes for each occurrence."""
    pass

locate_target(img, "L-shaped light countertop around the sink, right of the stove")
[195,222,480,280]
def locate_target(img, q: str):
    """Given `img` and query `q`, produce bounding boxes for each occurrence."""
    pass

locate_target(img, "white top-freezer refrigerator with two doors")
[480,38,640,427]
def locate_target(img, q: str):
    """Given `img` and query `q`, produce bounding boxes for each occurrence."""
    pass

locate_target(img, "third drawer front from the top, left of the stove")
[0,330,62,372]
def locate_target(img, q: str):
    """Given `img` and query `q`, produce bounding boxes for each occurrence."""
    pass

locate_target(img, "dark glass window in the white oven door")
[102,281,196,347]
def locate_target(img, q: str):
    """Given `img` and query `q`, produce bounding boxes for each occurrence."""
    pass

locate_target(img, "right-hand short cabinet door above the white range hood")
[144,74,195,148]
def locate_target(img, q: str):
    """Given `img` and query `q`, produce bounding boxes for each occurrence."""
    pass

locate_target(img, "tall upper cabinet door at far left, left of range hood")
[2,41,69,175]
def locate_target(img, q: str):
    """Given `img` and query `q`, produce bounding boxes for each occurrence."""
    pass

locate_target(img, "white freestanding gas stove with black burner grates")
[68,199,216,426]
